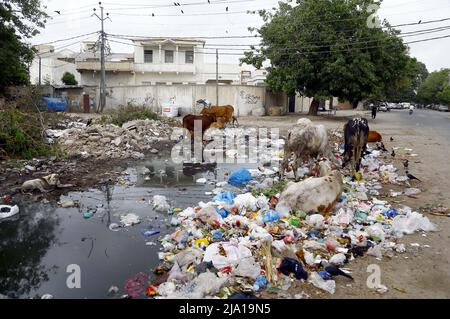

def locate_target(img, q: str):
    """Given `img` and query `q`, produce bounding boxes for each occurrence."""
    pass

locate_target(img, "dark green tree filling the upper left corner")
[0,0,48,91]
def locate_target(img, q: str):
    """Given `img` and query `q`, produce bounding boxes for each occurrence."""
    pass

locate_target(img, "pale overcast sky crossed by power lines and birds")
[30,0,450,71]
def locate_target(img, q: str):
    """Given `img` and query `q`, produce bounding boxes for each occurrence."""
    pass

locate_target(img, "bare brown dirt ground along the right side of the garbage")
[239,111,450,299]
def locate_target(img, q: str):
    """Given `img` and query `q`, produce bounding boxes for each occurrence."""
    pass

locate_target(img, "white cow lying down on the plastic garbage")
[276,160,344,214]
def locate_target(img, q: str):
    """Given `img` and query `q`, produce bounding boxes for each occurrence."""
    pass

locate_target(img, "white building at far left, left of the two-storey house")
[30,45,81,85]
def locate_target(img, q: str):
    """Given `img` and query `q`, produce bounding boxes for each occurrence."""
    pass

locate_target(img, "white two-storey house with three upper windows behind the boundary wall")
[76,38,260,86]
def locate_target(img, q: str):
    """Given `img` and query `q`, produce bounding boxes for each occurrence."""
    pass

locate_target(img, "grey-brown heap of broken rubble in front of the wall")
[47,119,172,160]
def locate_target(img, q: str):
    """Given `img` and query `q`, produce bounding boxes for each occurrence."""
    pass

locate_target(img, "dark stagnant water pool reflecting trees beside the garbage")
[0,160,257,298]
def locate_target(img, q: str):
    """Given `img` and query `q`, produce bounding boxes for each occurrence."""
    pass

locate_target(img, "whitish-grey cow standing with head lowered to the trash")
[280,119,328,181]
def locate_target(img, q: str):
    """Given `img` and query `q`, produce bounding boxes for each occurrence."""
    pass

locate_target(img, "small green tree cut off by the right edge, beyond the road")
[417,69,450,104]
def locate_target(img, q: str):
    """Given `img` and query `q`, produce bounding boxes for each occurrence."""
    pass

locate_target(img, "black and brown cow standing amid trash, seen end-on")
[342,118,369,171]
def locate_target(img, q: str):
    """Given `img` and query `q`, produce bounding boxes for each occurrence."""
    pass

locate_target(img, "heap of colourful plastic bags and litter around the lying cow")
[127,131,437,298]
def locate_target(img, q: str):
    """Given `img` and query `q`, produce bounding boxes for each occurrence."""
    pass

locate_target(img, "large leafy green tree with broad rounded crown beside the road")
[241,0,409,115]
